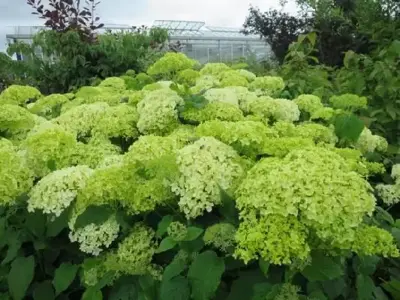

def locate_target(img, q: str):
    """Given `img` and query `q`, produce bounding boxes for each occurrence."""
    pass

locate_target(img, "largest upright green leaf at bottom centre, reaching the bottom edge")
[188,251,225,300]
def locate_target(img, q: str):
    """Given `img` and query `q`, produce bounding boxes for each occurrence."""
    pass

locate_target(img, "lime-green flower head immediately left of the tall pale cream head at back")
[93,104,139,139]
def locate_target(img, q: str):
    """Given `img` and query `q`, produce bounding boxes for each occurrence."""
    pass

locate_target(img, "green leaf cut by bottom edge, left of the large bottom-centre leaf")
[160,275,190,300]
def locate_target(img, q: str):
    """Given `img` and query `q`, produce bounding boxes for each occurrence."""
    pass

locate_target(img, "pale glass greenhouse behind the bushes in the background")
[6,20,272,63]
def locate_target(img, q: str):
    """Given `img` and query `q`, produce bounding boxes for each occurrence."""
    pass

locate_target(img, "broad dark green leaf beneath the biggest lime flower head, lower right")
[302,252,343,281]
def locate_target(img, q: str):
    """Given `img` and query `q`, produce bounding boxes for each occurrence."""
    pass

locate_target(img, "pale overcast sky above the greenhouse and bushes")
[0,0,296,51]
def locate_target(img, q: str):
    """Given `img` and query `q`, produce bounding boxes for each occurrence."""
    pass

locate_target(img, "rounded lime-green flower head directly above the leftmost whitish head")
[22,124,77,177]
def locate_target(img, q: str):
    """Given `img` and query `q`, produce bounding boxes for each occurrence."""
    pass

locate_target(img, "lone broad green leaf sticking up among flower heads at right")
[334,114,364,142]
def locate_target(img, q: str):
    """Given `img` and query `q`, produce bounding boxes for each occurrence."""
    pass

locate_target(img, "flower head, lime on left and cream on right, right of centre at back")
[249,97,300,122]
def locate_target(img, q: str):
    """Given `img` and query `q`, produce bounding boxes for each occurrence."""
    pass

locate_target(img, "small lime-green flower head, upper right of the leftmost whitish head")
[71,137,121,168]
